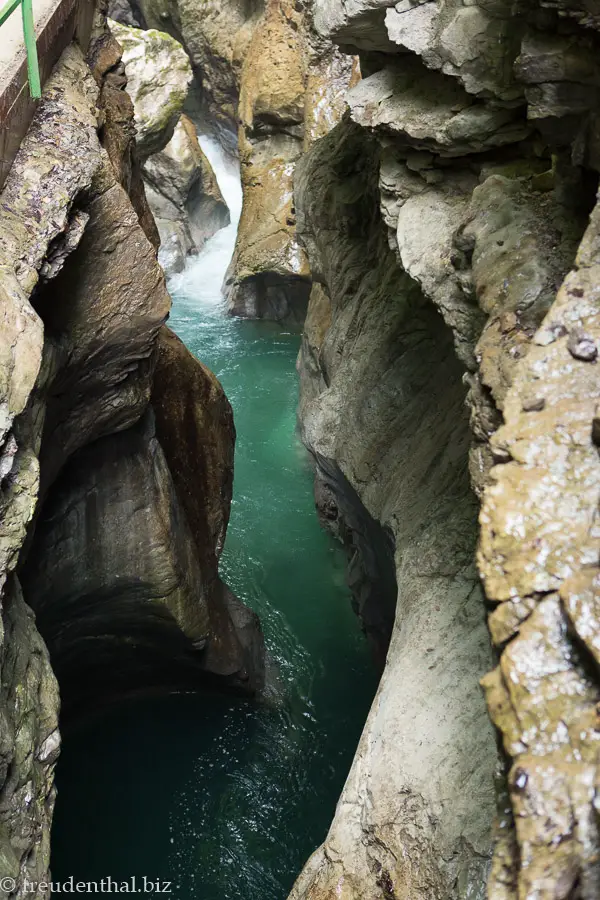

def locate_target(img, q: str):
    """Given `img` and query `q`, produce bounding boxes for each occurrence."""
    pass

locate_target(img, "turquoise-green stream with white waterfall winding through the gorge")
[52,140,376,900]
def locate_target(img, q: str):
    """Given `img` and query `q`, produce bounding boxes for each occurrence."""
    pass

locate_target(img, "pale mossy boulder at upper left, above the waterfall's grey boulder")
[110,20,192,159]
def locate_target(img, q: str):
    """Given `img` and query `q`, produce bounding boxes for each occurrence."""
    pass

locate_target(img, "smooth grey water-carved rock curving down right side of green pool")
[291,122,496,900]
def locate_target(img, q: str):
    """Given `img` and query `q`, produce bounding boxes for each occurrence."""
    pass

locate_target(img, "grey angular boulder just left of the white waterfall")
[144,115,229,273]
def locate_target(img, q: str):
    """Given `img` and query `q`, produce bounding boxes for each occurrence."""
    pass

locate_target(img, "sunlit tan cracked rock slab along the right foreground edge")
[479,208,600,900]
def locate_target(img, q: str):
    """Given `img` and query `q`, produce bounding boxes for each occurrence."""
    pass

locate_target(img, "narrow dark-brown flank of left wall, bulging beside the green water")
[152,328,264,691]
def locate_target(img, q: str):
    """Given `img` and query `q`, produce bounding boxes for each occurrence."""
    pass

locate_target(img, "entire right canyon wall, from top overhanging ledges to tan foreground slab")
[291,0,600,900]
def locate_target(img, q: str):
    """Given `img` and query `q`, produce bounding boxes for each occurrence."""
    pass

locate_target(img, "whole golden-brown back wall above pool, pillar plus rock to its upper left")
[119,0,357,323]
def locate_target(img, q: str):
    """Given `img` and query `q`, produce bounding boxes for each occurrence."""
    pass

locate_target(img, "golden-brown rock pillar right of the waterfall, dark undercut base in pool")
[226,0,354,321]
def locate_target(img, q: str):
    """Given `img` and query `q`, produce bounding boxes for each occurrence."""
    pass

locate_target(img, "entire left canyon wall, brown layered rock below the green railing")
[0,9,264,898]
